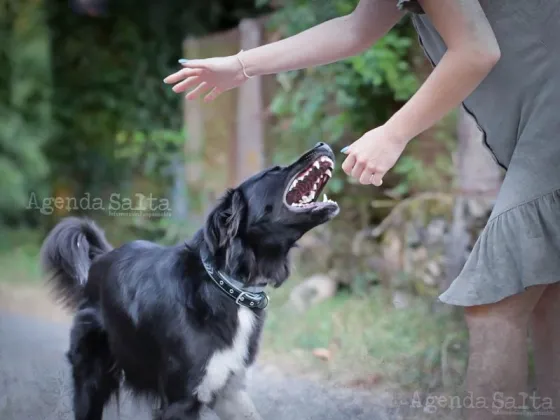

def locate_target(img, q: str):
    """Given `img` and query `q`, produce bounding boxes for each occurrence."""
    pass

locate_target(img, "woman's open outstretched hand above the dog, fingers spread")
[163,55,247,102]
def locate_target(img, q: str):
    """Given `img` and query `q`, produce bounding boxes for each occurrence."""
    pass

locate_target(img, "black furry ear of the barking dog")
[204,190,247,253]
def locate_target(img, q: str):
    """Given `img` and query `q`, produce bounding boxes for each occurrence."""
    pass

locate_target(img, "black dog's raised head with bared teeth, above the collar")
[204,143,339,287]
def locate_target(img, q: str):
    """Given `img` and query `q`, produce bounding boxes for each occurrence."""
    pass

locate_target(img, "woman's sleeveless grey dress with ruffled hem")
[398,0,560,306]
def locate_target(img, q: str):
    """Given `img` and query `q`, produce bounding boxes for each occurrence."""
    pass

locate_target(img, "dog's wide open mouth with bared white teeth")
[285,156,338,211]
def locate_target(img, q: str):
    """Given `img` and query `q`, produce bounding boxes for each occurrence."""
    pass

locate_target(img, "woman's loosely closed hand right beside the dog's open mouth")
[342,126,408,187]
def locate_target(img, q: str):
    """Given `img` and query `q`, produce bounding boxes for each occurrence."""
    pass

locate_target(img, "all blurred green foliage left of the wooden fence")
[0,0,266,230]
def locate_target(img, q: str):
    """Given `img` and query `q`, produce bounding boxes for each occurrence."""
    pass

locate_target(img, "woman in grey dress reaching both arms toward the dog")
[165,0,560,420]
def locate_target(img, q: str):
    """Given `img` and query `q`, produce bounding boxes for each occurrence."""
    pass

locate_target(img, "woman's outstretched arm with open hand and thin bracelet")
[164,0,403,101]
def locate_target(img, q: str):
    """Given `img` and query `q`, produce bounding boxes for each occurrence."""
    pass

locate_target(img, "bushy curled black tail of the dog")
[41,217,113,309]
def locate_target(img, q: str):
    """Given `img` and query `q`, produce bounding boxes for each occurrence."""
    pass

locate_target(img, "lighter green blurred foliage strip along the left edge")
[0,0,51,222]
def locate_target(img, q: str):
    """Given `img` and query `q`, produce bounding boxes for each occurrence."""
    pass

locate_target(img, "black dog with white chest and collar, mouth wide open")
[41,143,339,420]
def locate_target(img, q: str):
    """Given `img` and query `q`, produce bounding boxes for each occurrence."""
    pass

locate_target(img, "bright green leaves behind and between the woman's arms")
[264,0,418,154]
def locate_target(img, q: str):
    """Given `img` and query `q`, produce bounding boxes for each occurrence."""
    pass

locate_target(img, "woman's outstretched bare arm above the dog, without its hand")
[240,0,402,76]
